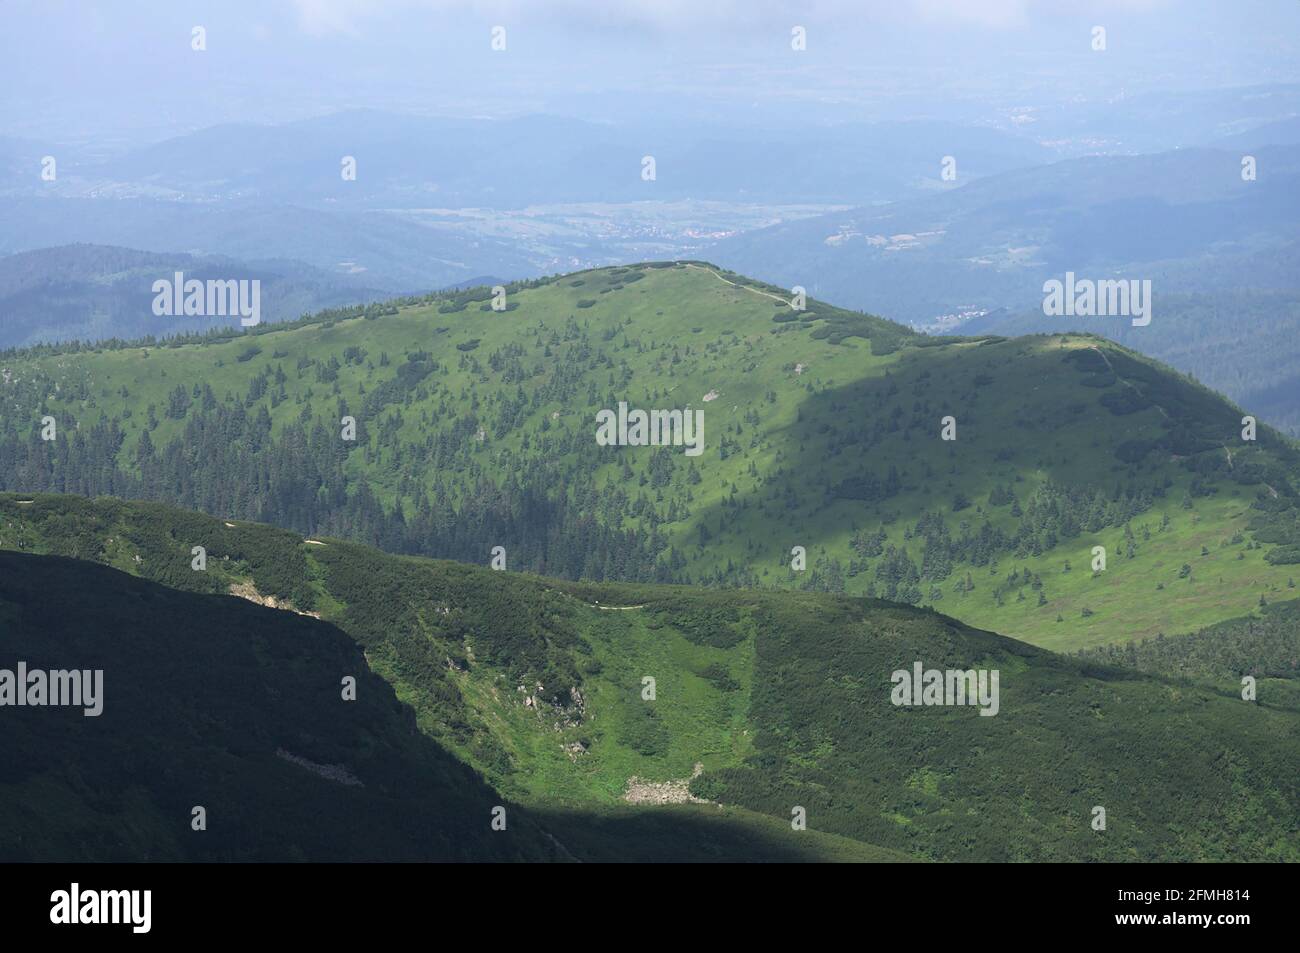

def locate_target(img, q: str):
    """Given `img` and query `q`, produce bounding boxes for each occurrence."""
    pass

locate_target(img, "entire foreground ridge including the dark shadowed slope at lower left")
[0,494,1300,861]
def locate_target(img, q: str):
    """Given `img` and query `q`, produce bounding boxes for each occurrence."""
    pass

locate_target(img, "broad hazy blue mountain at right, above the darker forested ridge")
[709,147,1300,325]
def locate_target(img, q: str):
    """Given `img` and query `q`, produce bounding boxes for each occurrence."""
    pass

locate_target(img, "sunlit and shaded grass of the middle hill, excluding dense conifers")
[0,264,1295,649]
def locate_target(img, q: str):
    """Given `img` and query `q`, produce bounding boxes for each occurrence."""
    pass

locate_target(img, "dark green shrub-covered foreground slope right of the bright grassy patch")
[692,593,1300,861]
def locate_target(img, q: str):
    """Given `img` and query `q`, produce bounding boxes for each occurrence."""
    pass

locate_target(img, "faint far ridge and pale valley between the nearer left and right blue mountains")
[0,109,1053,294]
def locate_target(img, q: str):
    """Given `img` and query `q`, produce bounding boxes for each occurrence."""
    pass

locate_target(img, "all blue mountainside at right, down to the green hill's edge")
[709,144,1300,433]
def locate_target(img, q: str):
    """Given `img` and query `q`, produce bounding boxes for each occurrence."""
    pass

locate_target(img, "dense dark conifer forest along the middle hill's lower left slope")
[0,403,667,579]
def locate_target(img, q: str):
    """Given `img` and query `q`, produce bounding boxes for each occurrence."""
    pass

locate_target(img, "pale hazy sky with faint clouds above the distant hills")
[0,0,1300,144]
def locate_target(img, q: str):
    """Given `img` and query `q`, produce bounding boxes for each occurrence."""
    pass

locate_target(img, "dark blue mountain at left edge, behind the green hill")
[0,244,387,347]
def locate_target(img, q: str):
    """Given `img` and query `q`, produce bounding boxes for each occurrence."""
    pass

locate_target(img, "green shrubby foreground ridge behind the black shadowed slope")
[0,495,1300,861]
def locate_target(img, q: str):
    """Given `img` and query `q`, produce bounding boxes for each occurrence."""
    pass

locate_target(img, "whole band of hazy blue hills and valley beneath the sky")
[12,105,1300,371]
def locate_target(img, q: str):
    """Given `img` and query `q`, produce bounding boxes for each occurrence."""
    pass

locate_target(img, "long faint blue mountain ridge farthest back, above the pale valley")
[40,109,1052,208]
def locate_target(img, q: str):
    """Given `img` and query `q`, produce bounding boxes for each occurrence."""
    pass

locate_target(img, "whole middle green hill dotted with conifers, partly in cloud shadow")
[0,263,1300,649]
